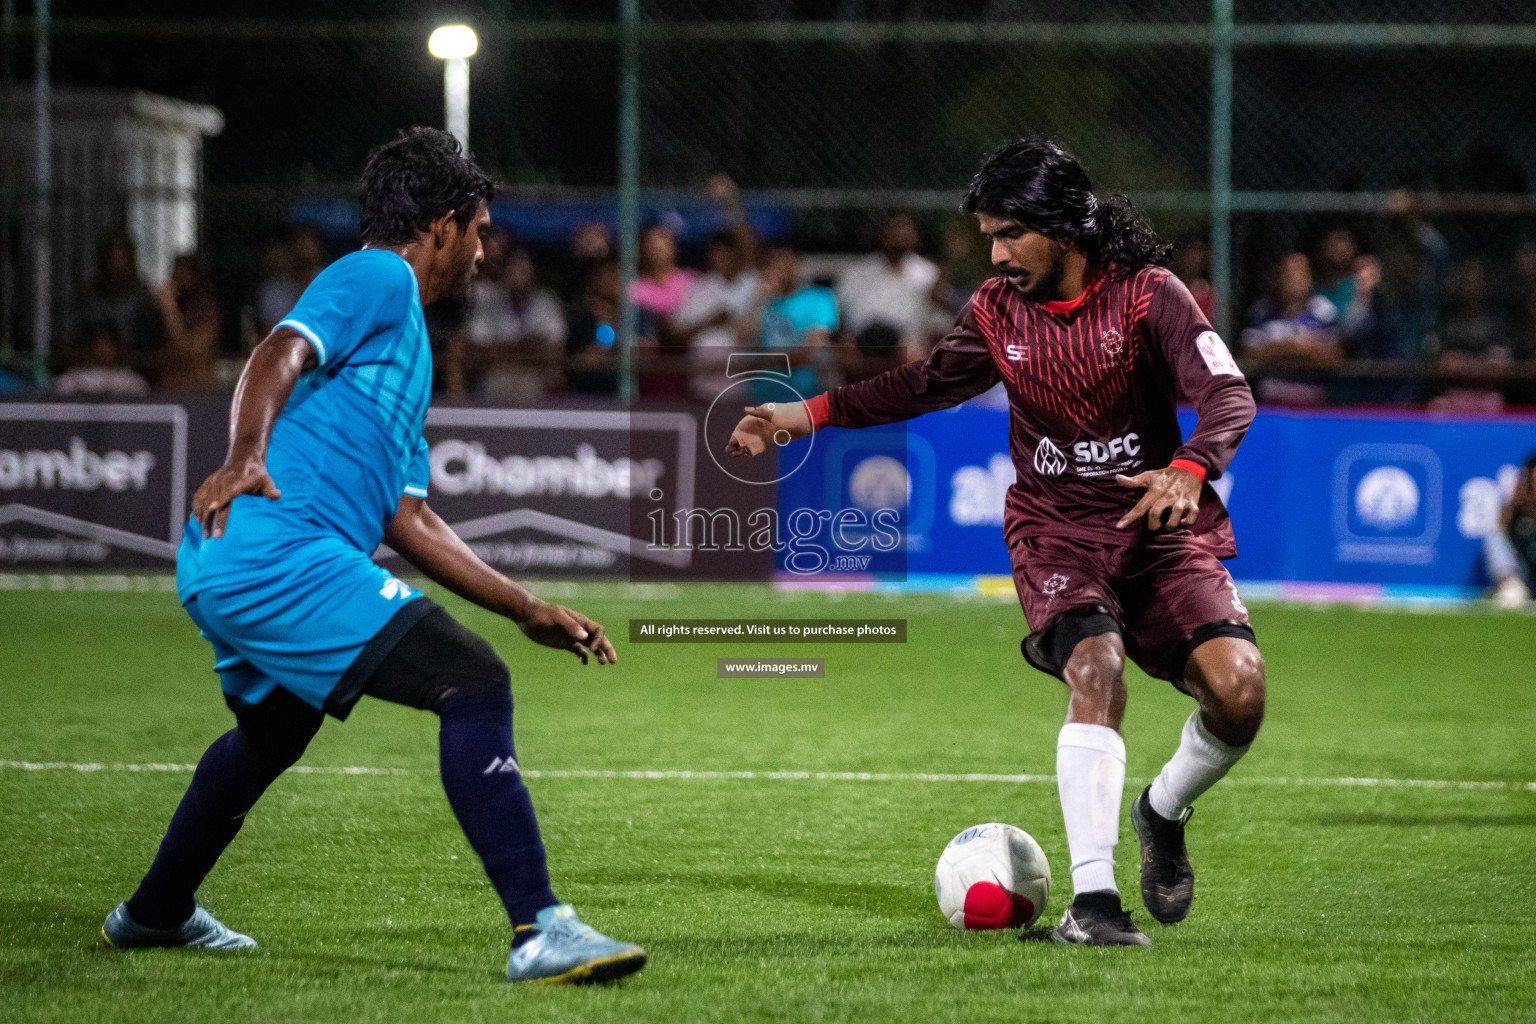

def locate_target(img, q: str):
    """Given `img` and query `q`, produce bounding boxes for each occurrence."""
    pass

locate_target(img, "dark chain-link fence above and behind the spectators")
[0,0,1536,398]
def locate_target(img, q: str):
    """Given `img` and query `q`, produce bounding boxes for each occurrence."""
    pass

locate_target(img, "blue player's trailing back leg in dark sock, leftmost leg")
[101,688,324,949]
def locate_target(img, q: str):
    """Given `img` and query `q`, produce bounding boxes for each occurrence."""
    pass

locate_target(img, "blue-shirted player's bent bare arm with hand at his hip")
[192,327,315,537]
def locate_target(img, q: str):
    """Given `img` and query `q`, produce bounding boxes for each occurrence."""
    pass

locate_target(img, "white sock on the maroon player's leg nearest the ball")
[1057,722,1126,894]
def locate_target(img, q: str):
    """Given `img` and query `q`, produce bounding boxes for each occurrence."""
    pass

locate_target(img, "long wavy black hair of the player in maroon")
[960,138,1174,275]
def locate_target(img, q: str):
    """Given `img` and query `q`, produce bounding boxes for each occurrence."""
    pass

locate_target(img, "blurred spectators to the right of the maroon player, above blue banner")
[1240,192,1536,413]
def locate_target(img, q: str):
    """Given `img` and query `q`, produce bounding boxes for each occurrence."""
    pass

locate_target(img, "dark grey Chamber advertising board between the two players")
[396,404,777,580]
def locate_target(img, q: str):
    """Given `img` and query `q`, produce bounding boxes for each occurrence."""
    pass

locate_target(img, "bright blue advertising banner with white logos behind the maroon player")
[779,405,1536,597]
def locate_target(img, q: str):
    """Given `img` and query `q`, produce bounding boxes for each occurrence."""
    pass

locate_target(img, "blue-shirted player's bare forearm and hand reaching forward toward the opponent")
[384,494,619,665]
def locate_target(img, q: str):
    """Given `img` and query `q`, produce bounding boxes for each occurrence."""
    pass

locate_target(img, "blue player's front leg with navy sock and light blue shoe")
[362,608,645,983]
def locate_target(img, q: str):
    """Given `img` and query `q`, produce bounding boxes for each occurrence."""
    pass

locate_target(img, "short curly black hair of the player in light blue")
[358,126,496,246]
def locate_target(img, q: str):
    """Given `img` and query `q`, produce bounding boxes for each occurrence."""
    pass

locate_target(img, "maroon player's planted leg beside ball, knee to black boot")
[1041,609,1149,946]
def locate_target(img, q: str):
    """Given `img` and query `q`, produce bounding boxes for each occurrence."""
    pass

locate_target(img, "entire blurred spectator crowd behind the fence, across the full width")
[18,175,1536,411]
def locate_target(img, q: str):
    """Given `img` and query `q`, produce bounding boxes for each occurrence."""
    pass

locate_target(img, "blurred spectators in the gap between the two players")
[439,175,986,405]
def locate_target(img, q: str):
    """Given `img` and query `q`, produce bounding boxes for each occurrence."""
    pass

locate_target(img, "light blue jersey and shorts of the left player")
[177,249,445,715]
